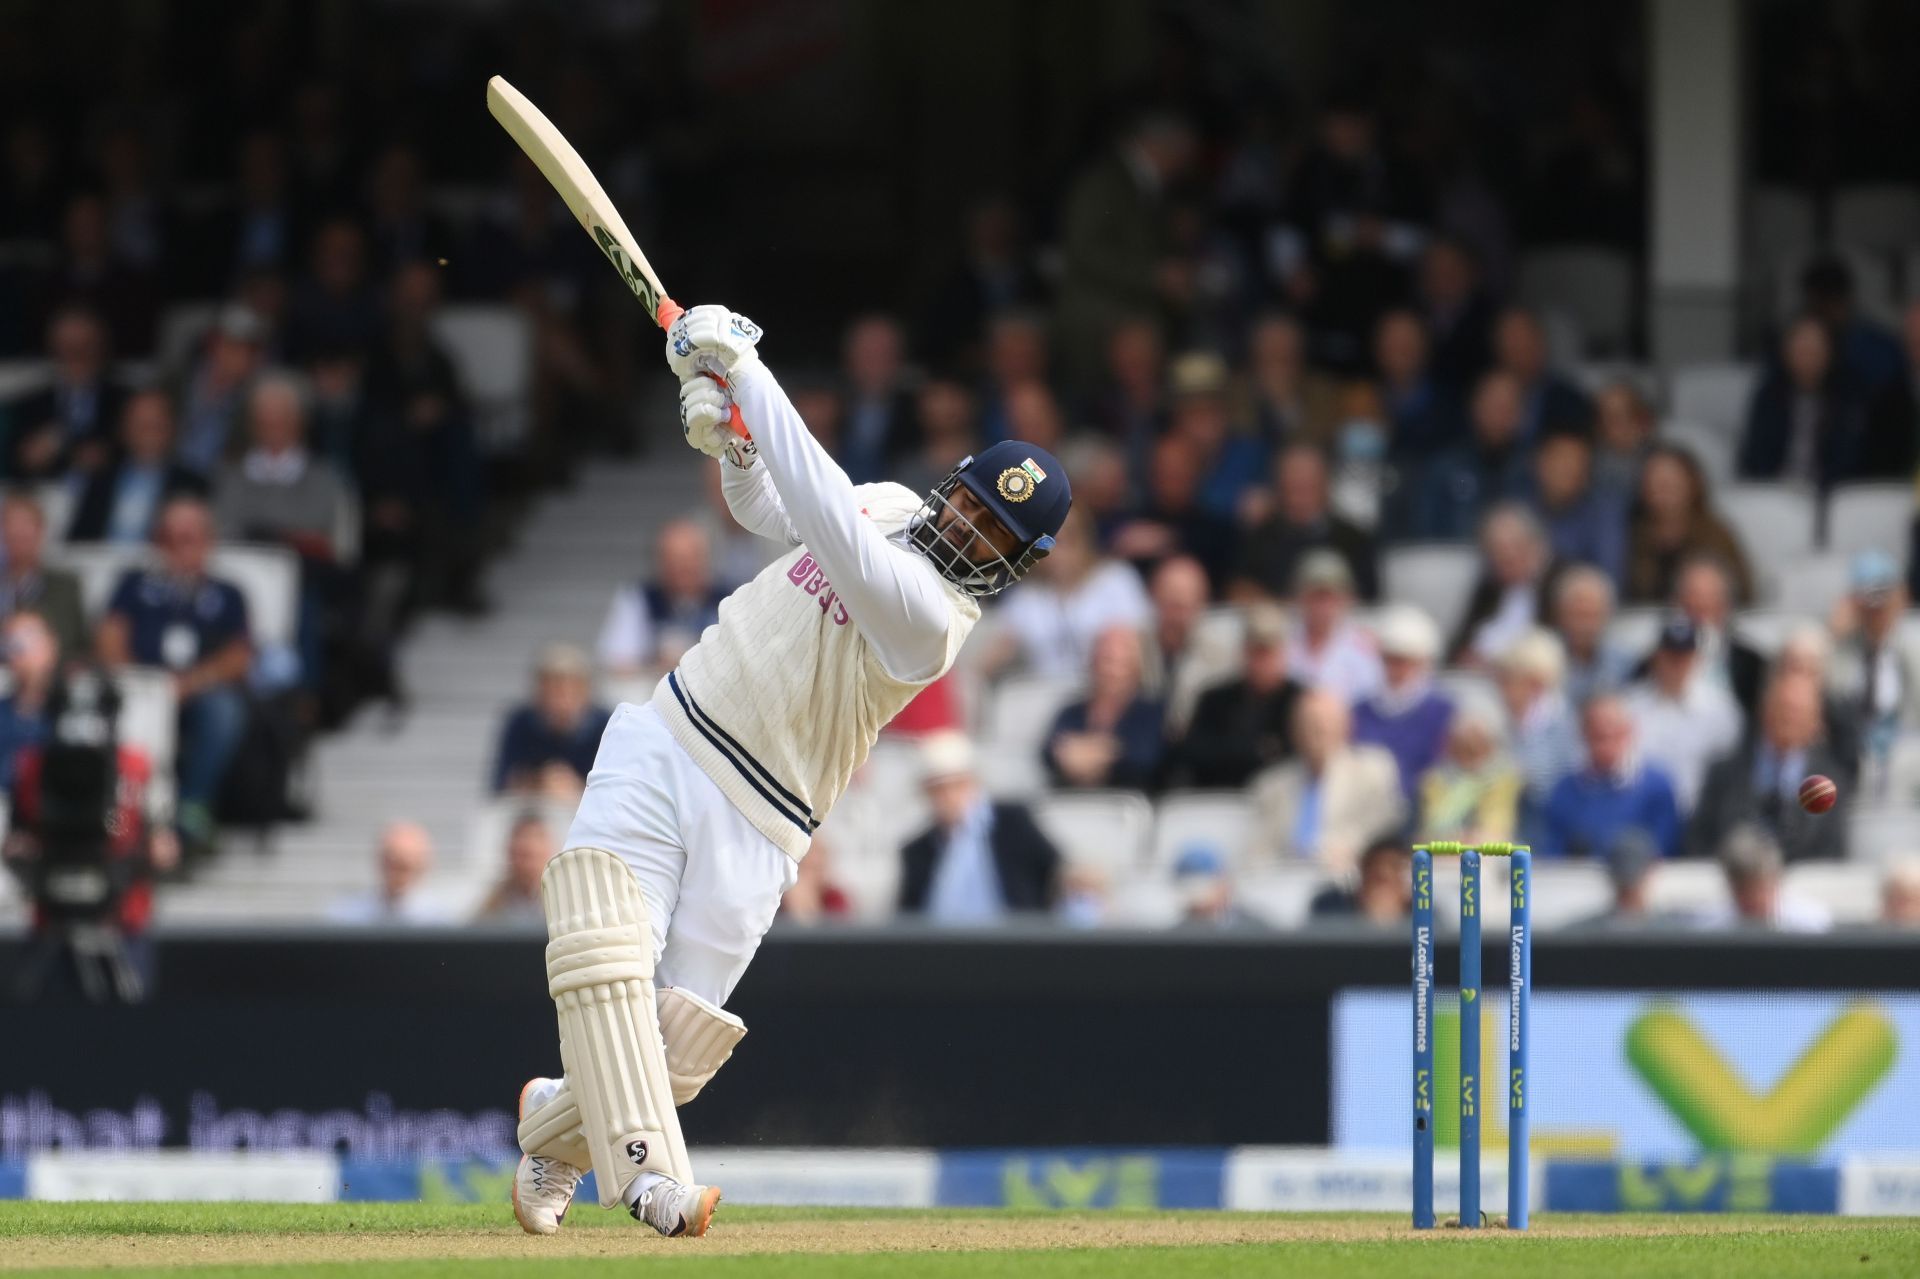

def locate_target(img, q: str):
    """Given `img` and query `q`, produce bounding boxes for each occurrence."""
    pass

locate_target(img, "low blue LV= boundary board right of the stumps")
[1540,1154,1839,1214]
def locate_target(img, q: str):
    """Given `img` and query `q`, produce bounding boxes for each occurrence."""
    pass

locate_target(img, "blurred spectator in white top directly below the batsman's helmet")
[981,511,1152,680]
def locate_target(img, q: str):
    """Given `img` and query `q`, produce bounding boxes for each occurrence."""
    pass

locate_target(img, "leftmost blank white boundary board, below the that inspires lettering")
[23,1150,340,1204]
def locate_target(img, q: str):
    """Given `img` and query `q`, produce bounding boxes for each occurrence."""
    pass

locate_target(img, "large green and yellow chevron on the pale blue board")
[1626,1001,1899,1154]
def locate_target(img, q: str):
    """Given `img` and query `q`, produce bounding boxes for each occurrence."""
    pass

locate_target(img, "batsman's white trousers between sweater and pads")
[564,703,799,1006]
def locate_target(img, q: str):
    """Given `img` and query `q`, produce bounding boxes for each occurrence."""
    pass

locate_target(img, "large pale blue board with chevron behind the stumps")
[1331,974,1920,1164]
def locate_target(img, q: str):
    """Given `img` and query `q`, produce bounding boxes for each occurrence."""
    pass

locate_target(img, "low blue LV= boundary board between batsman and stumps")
[937,1148,1227,1208]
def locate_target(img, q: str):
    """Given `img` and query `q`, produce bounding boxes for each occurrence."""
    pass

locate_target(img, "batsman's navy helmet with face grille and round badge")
[908,440,1073,595]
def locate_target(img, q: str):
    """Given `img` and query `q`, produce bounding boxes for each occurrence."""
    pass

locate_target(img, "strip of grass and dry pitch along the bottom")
[0,1204,1920,1279]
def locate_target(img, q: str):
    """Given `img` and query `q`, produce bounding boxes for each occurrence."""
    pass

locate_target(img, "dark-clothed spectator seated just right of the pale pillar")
[1738,315,1868,490]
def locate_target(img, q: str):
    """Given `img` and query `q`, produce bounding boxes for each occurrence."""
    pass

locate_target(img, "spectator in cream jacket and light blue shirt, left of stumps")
[1248,689,1405,874]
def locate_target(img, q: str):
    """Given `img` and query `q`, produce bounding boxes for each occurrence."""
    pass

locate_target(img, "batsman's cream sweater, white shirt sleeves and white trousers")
[566,353,979,1004]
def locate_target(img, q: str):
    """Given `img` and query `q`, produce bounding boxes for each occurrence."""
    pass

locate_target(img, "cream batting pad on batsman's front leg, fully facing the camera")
[540,849,693,1208]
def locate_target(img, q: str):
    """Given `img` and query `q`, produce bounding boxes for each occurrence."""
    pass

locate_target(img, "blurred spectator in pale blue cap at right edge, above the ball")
[1828,549,1920,762]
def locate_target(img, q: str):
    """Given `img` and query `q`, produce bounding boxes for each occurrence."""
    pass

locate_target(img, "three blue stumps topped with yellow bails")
[1413,843,1534,1231]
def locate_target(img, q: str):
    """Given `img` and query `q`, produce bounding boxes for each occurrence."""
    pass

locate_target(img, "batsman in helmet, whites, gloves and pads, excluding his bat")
[513,305,1071,1237]
